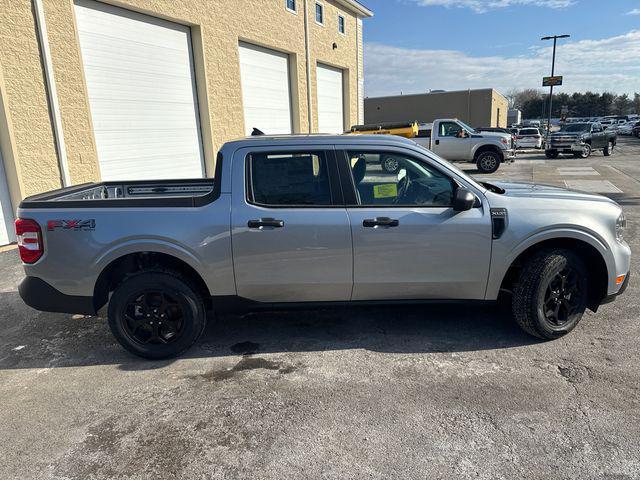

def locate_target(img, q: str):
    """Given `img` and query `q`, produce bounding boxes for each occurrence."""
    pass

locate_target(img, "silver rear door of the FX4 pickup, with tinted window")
[231,145,353,303]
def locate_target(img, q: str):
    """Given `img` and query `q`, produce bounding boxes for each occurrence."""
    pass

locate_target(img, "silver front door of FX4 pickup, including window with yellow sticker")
[339,146,492,300]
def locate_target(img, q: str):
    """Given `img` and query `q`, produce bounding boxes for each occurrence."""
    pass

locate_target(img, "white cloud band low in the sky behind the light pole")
[365,30,640,97]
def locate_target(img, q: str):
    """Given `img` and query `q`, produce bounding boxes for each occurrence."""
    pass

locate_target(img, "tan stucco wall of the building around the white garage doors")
[0,0,358,196]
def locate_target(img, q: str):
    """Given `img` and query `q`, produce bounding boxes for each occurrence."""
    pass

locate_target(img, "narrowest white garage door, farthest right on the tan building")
[316,65,345,133]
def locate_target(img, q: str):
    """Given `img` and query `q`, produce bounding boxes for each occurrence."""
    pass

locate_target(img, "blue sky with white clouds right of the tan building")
[361,0,640,97]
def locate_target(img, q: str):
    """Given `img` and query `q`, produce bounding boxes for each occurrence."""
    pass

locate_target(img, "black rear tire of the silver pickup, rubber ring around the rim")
[108,272,206,359]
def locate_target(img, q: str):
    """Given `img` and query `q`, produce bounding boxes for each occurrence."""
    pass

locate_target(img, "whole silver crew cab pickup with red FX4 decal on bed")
[16,135,631,358]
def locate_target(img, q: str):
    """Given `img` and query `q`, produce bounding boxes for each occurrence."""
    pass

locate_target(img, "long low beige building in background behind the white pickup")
[364,88,509,128]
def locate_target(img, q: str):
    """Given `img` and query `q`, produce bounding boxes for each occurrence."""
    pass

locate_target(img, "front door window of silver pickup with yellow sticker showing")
[348,151,455,207]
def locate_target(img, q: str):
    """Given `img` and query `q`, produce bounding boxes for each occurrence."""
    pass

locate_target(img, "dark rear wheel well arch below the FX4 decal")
[93,252,211,311]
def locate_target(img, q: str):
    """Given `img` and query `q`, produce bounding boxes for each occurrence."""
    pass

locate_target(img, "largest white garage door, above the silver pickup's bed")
[75,0,204,180]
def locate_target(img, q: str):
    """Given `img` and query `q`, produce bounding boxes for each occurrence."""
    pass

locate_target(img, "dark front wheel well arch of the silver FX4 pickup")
[500,238,608,311]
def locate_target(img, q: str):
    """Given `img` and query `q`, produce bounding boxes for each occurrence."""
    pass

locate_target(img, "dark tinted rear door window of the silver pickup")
[248,152,332,206]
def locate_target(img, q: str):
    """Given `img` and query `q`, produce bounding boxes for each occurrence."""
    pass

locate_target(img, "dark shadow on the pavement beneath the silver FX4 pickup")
[0,292,536,371]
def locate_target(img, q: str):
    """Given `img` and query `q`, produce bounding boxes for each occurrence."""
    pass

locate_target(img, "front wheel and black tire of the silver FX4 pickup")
[512,249,589,340]
